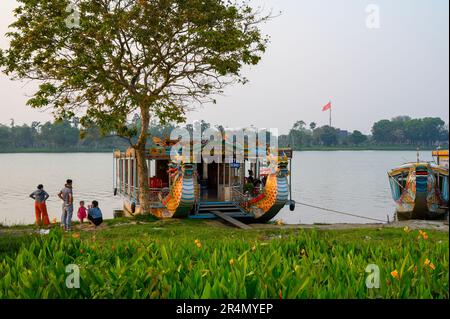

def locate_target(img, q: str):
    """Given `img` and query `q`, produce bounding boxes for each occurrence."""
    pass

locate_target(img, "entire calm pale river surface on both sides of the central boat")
[0,151,432,225]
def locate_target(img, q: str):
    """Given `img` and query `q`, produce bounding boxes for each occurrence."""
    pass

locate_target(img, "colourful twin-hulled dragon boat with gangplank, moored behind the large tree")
[113,141,295,223]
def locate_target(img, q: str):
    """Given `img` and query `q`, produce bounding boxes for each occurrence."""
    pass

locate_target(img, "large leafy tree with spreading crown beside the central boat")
[0,0,269,213]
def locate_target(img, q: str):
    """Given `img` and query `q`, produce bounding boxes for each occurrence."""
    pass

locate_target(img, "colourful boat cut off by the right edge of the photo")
[388,151,449,220]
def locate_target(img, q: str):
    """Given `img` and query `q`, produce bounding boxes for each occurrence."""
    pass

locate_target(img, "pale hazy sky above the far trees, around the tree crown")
[0,0,449,133]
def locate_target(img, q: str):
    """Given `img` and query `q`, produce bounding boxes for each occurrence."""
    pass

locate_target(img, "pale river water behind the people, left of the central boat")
[0,153,121,224]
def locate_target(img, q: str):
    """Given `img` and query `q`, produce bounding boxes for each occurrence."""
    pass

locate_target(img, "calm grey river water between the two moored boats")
[276,151,432,224]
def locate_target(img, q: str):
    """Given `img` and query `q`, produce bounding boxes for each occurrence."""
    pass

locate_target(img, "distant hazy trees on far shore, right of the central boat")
[279,116,449,149]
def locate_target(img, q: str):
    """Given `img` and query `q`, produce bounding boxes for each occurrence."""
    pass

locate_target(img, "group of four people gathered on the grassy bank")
[30,179,103,231]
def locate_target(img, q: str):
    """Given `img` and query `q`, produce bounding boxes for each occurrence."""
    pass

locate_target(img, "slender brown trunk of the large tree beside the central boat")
[134,107,151,215]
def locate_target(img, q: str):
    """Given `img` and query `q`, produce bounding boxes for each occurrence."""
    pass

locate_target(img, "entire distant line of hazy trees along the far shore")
[0,115,449,152]
